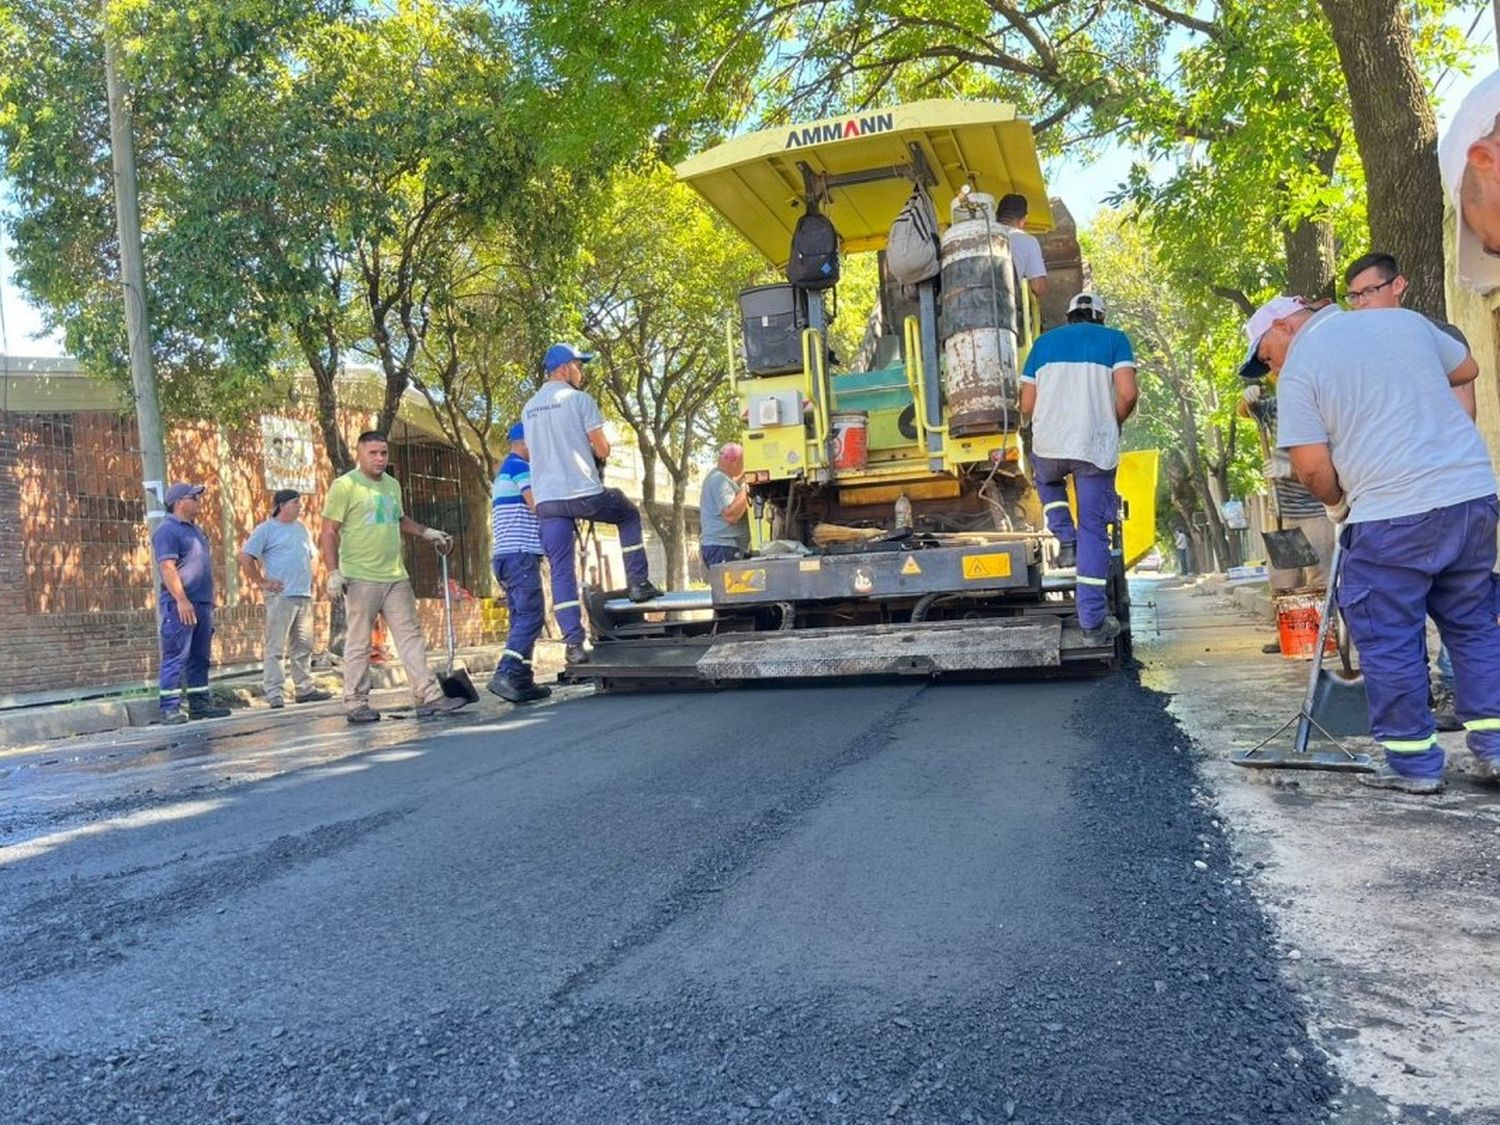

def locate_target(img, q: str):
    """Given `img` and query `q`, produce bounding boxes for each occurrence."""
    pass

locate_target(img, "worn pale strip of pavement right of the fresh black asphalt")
[1136,579,1500,1125]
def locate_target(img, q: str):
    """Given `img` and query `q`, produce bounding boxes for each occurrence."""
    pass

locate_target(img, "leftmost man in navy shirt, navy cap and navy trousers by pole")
[152,482,230,723]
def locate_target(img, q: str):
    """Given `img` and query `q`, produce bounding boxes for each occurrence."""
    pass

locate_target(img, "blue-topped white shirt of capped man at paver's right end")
[1022,324,1136,470]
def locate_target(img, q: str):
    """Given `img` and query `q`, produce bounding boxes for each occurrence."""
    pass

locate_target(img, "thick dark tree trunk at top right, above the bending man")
[1320,0,1448,318]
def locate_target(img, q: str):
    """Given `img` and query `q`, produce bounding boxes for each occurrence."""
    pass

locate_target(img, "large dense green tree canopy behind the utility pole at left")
[0,0,594,470]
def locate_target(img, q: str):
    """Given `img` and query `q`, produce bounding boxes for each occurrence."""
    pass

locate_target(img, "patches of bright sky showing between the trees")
[0,15,1496,356]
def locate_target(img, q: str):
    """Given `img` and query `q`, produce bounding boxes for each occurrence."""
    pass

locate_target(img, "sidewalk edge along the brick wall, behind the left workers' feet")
[0,641,564,758]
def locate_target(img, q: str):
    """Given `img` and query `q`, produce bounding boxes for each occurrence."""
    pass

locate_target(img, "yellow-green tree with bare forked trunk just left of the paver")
[581,164,765,588]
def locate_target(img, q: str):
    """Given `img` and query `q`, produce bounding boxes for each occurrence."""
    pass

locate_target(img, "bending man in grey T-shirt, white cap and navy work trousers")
[1241,299,1500,794]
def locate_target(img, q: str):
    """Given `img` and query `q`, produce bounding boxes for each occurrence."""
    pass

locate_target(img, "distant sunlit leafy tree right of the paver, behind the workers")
[1080,210,1259,567]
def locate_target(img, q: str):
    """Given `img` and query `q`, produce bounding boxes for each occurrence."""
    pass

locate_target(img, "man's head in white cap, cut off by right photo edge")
[1437,71,1500,293]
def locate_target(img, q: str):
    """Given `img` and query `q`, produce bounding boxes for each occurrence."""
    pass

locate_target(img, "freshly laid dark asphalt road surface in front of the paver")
[0,648,1334,1125]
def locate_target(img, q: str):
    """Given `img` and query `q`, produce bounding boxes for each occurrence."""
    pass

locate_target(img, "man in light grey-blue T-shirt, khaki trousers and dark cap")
[240,489,333,710]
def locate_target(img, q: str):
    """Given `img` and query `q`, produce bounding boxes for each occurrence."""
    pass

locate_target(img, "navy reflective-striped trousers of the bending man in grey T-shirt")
[1338,497,1500,777]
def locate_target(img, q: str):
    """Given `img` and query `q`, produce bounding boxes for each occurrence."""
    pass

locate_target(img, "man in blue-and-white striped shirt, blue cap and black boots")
[488,422,552,704]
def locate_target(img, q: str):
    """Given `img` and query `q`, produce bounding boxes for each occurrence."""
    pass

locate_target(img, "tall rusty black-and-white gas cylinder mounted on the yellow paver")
[939,192,1022,437]
